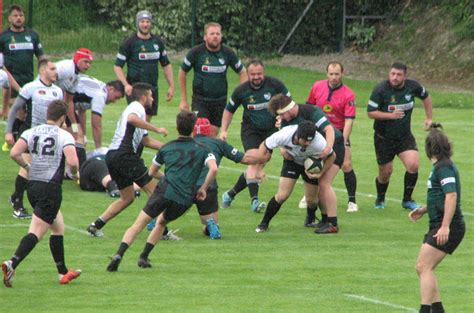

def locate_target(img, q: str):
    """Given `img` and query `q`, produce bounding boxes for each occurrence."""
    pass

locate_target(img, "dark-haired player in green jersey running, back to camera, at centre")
[107,111,217,272]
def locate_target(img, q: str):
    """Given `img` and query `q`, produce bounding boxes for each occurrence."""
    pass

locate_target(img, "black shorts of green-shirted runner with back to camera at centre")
[143,179,190,222]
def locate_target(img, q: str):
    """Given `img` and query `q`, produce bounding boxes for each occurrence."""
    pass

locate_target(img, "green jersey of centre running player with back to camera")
[153,137,215,206]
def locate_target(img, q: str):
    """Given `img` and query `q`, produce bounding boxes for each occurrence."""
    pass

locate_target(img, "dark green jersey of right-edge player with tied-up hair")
[426,159,464,229]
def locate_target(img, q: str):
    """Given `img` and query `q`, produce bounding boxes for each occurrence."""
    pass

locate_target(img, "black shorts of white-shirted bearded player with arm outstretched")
[105,150,152,190]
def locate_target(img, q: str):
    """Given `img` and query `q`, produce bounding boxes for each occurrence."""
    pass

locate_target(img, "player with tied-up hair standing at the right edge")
[409,123,466,313]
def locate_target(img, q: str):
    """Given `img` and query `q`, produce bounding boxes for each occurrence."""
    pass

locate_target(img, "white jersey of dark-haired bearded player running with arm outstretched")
[109,101,148,152]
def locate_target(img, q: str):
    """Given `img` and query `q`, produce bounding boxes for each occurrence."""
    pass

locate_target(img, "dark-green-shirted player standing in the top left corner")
[0,4,43,147]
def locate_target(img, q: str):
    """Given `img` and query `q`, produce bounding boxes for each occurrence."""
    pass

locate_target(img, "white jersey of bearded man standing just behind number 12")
[20,78,63,127]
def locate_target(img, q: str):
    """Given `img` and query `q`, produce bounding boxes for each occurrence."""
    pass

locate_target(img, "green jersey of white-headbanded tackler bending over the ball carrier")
[281,104,342,140]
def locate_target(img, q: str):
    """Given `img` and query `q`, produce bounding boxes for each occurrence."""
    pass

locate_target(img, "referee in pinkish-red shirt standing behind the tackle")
[305,62,359,212]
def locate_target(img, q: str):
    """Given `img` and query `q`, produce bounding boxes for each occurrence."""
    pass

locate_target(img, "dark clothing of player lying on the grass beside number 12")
[79,158,109,191]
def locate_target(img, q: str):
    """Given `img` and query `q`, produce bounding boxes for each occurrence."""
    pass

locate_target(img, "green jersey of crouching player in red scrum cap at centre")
[194,135,244,189]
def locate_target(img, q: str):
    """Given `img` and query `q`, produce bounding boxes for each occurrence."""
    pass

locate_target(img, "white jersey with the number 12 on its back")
[20,124,74,184]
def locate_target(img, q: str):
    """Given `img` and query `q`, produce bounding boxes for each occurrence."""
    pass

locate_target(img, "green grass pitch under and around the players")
[0,60,474,312]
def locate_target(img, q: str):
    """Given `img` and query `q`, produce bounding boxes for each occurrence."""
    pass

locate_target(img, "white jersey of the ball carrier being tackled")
[265,125,332,165]
